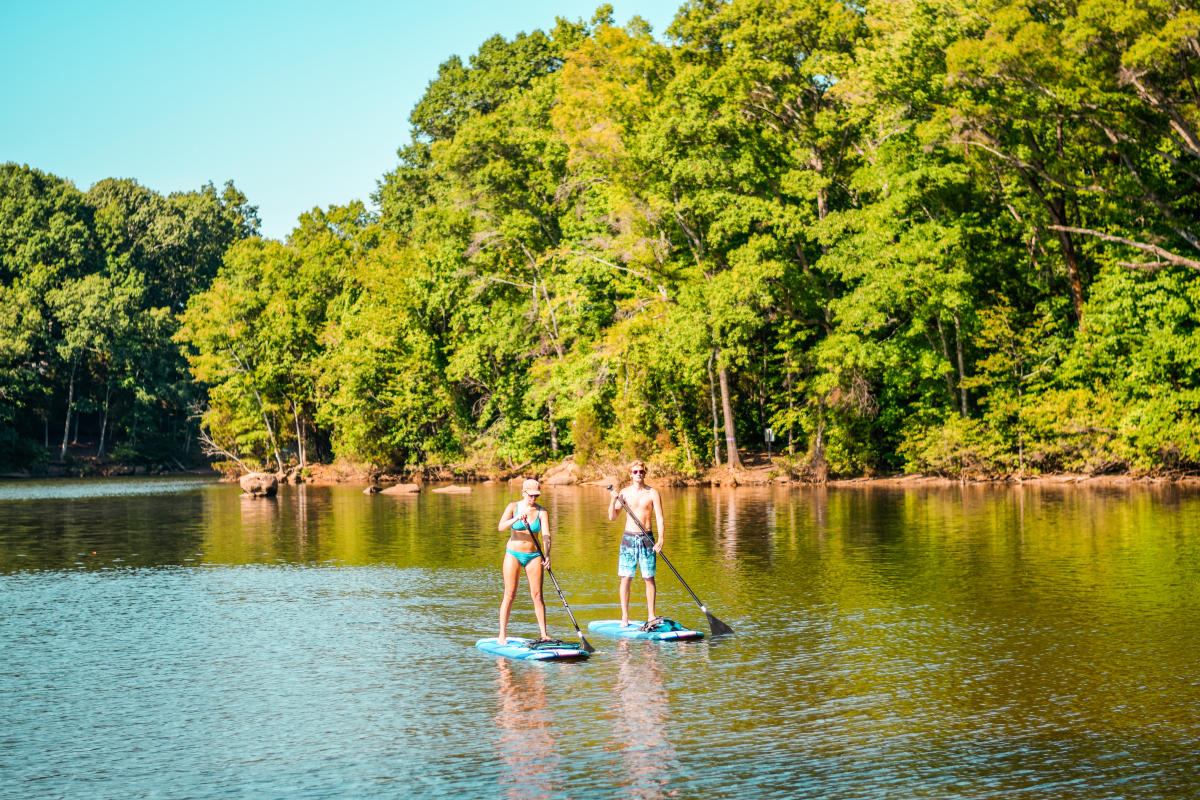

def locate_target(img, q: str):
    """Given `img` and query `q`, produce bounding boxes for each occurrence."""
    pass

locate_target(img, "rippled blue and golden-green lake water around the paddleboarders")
[0,479,1200,800]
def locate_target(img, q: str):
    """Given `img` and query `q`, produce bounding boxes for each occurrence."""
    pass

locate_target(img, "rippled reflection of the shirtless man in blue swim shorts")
[608,639,679,800]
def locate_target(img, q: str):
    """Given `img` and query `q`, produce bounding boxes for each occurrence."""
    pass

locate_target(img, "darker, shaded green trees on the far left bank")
[0,163,258,468]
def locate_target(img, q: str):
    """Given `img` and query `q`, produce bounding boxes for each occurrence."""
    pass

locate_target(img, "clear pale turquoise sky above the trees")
[0,0,682,239]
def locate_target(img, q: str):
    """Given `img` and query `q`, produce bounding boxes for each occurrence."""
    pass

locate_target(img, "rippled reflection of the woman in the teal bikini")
[493,658,562,800]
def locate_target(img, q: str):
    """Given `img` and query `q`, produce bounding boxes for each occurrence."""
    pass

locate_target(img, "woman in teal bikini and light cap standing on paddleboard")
[496,477,550,644]
